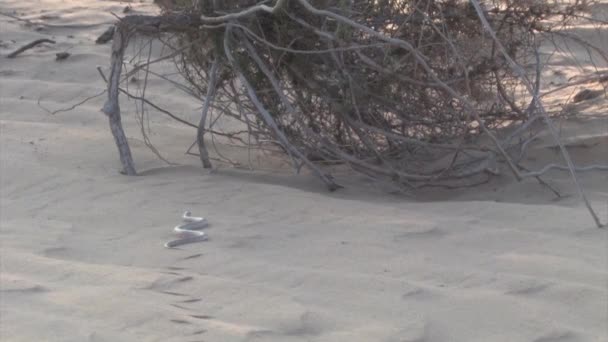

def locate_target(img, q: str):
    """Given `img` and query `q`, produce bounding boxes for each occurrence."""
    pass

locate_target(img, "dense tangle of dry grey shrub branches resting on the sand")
[102,0,604,224]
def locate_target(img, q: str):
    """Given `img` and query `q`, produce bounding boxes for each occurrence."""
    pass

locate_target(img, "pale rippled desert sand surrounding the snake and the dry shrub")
[0,0,608,342]
